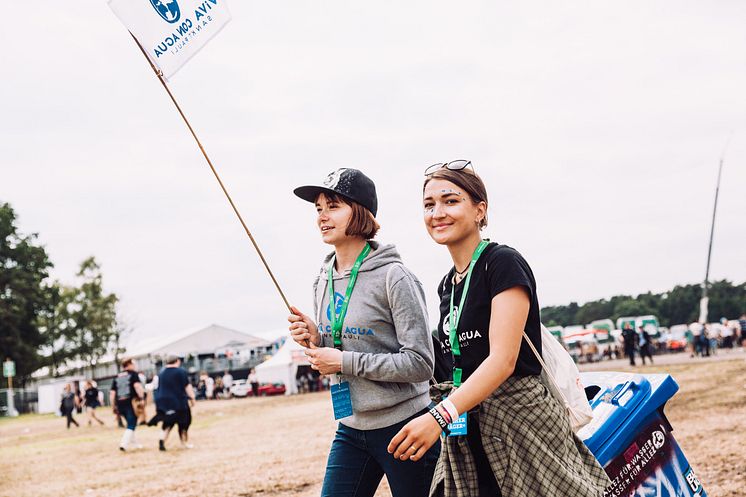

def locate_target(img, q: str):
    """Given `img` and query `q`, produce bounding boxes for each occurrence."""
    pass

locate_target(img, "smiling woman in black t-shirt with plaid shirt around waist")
[389,161,609,497]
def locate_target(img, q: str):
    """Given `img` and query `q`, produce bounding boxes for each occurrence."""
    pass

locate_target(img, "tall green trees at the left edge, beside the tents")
[0,203,124,385]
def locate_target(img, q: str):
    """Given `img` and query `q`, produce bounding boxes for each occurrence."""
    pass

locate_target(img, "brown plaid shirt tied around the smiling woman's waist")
[430,376,610,497]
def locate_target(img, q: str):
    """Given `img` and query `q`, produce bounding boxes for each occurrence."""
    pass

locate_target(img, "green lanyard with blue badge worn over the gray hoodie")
[327,243,371,419]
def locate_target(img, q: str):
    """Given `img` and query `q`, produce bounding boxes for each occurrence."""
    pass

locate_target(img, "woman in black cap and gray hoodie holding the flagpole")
[288,169,439,497]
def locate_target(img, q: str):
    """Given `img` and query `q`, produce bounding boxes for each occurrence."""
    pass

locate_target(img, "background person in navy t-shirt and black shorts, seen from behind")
[155,355,195,450]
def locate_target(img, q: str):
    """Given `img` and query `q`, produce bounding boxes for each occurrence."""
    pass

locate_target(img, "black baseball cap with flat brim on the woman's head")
[293,167,378,216]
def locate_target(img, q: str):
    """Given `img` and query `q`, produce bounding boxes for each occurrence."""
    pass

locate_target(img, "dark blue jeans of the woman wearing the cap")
[321,411,440,497]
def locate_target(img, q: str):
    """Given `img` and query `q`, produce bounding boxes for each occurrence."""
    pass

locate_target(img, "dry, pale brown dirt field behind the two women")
[0,355,746,497]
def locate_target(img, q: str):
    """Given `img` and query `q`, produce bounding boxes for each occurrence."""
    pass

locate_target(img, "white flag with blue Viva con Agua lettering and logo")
[109,0,231,79]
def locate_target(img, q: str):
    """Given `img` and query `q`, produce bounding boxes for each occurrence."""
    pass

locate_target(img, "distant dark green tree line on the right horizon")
[541,280,746,326]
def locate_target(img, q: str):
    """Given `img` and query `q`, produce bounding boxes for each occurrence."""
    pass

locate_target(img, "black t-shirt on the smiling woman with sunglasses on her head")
[430,242,541,381]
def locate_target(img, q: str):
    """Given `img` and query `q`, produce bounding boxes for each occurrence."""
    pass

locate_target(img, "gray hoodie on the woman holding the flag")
[313,242,434,430]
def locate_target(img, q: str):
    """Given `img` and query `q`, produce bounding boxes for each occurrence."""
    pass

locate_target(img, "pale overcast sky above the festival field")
[0,0,746,346]
